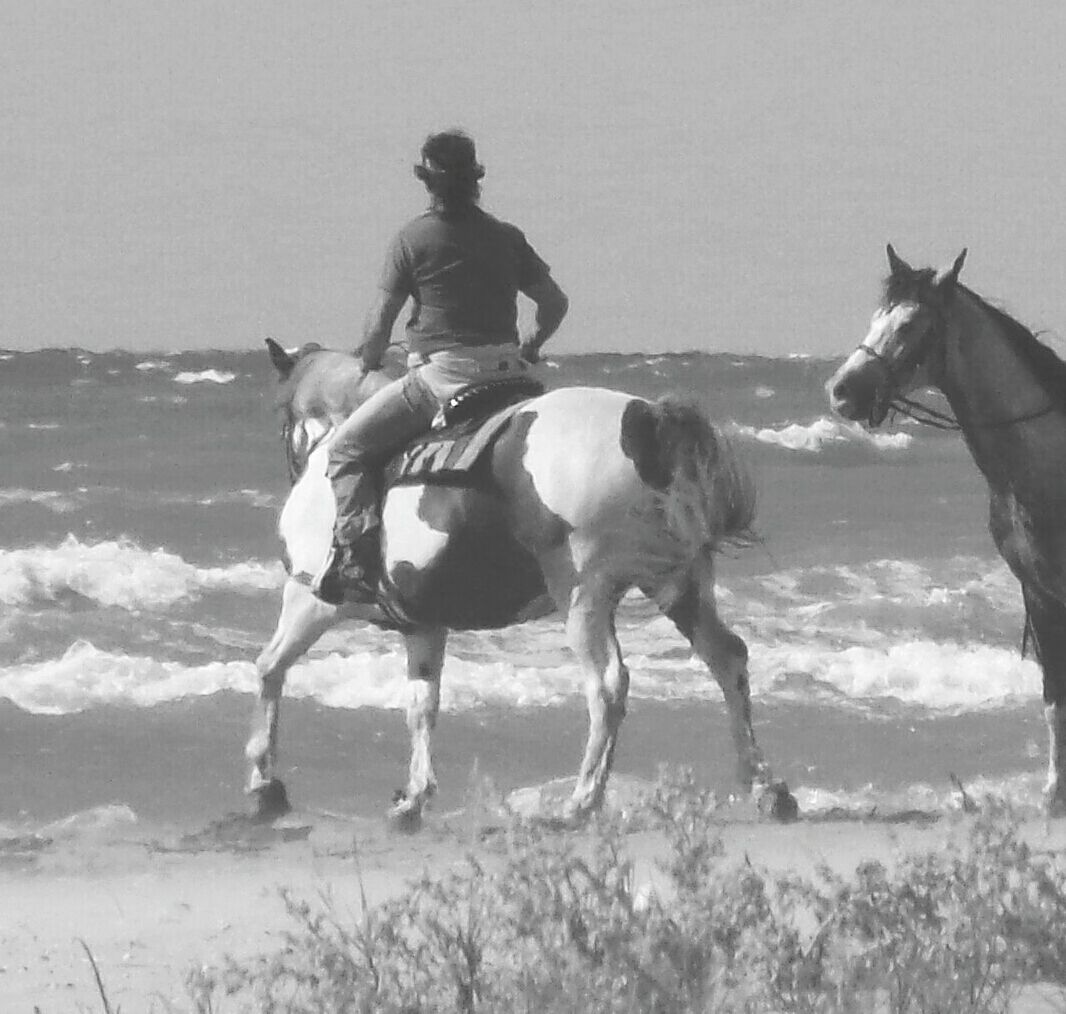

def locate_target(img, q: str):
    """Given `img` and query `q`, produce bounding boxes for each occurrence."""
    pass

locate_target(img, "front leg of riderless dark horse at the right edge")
[1021,583,1066,816]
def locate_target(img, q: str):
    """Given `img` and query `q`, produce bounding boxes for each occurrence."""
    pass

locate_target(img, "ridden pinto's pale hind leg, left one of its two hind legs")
[566,583,629,817]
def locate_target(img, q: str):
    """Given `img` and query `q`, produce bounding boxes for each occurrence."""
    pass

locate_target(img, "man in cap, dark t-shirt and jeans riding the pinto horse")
[312,130,568,605]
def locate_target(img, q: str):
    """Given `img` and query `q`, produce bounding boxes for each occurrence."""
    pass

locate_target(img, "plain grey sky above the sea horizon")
[0,0,1066,355]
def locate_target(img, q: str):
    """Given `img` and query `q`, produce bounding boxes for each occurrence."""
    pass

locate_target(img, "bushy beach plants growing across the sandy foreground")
[179,772,1066,1014]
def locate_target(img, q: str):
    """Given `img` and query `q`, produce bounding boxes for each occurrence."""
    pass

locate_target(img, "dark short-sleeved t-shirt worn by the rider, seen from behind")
[381,207,548,354]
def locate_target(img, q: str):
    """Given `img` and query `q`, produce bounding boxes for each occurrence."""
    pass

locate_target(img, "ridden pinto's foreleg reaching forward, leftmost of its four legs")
[244,580,340,820]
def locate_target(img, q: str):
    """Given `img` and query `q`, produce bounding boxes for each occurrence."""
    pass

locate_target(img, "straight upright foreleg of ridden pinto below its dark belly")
[389,627,448,831]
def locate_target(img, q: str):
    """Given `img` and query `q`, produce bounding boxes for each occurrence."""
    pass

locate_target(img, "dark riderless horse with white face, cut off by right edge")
[826,246,1066,814]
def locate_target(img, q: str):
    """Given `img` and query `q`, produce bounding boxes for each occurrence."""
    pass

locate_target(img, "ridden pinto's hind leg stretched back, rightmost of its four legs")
[664,560,796,820]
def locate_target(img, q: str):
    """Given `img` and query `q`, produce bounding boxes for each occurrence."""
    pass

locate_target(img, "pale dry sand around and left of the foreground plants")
[8,785,1066,1014]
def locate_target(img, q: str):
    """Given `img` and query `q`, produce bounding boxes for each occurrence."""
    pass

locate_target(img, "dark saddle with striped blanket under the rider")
[385,376,544,488]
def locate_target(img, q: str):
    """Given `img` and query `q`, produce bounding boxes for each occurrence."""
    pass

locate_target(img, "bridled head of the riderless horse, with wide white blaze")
[826,244,966,426]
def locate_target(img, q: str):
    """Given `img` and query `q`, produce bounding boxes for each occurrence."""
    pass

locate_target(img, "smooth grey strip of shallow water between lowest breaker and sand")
[0,693,1047,835]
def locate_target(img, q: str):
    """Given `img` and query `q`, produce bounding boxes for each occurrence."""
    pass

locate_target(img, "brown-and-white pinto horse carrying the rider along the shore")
[246,341,795,830]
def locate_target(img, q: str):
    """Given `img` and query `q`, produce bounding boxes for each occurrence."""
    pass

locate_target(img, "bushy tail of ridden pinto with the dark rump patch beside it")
[623,397,756,554]
